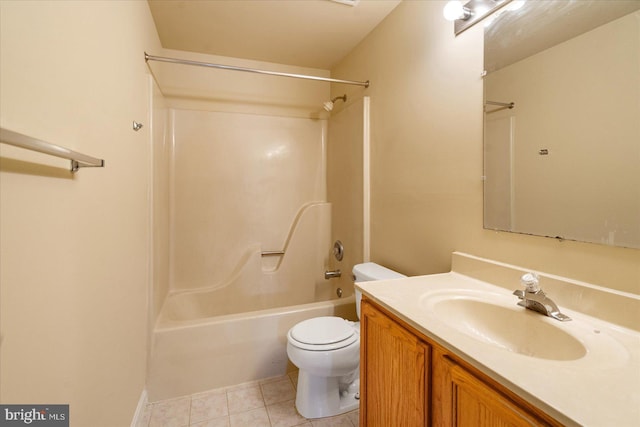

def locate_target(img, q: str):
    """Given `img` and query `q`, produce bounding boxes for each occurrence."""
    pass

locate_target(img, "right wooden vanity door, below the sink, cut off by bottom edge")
[433,349,558,427]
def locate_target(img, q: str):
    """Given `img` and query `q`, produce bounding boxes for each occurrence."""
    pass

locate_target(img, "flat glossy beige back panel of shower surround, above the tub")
[170,110,329,292]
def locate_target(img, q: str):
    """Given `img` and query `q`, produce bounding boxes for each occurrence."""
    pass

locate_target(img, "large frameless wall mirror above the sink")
[484,0,640,248]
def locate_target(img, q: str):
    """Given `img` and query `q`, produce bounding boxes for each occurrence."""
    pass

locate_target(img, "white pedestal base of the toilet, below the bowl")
[296,371,360,418]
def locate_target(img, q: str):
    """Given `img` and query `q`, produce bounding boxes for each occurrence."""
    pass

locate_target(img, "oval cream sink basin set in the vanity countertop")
[422,291,587,361]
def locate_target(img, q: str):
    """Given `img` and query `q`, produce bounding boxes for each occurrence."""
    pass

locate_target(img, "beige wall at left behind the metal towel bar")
[0,0,159,427]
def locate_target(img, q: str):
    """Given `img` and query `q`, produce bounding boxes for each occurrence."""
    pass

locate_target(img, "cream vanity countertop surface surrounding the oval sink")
[356,272,640,427]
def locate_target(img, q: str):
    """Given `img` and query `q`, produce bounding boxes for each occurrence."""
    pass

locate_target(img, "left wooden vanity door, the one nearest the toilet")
[360,300,429,427]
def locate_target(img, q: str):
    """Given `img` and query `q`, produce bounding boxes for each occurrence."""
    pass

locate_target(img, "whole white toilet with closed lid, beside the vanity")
[287,262,406,418]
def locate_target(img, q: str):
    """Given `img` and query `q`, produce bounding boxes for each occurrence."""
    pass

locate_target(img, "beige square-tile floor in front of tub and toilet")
[138,371,359,427]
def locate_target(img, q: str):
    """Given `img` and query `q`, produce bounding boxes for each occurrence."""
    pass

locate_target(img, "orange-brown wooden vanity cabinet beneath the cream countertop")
[360,297,562,427]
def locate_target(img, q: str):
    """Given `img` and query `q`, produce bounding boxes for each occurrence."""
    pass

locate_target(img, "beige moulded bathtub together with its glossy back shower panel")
[148,109,355,401]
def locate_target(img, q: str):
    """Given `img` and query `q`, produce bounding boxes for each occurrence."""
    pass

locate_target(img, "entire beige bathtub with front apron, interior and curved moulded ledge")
[147,202,357,402]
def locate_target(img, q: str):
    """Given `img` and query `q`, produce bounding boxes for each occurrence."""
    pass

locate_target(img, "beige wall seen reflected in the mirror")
[485,12,640,248]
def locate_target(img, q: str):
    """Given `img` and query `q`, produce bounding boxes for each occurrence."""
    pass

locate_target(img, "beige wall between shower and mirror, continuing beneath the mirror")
[332,1,640,293]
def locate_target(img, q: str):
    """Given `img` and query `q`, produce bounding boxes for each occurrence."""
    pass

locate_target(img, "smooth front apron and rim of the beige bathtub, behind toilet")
[147,295,356,402]
